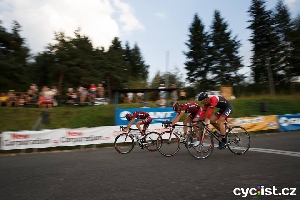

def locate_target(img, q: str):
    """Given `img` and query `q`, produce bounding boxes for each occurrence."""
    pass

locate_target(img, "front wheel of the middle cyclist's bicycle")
[157,131,180,157]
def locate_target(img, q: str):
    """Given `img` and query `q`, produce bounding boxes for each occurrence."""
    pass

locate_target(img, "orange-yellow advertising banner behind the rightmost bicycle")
[229,115,279,132]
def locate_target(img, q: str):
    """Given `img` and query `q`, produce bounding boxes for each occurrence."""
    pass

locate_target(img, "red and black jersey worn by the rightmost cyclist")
[200,95,233,119]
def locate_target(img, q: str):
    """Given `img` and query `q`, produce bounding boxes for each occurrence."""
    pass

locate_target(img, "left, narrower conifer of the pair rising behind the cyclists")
[183,14,210,89]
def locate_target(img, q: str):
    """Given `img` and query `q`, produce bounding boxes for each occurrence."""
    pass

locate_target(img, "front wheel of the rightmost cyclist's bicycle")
[185,131,214,159]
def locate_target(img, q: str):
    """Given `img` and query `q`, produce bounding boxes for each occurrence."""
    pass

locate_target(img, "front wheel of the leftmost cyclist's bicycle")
[114,133,134,154]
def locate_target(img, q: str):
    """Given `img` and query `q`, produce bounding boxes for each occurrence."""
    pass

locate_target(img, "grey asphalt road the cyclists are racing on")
[0,131,300,200]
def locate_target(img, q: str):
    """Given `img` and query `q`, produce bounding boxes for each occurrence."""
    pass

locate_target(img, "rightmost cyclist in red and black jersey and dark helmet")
[198,92,233,149]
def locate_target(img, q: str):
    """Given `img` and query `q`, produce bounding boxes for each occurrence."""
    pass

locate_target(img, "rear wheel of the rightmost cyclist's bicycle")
[227,126,250,155]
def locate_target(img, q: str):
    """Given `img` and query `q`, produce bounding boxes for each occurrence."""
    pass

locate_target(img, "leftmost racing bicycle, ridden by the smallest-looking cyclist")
[114,126,160,154]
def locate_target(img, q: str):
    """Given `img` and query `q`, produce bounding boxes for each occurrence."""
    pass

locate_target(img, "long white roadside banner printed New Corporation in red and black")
[0,124,169,150]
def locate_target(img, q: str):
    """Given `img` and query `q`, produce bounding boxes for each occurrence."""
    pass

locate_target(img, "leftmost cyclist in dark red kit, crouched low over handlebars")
[124,110,152,143]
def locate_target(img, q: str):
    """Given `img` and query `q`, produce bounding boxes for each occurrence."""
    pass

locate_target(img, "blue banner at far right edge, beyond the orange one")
[277,114,300,131]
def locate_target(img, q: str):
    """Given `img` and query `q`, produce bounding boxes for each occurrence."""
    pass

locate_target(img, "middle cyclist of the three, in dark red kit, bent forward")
[170,102,202,146]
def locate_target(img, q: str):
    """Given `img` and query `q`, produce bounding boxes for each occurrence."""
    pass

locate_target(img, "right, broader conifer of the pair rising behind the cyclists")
[209,10,244,86]
